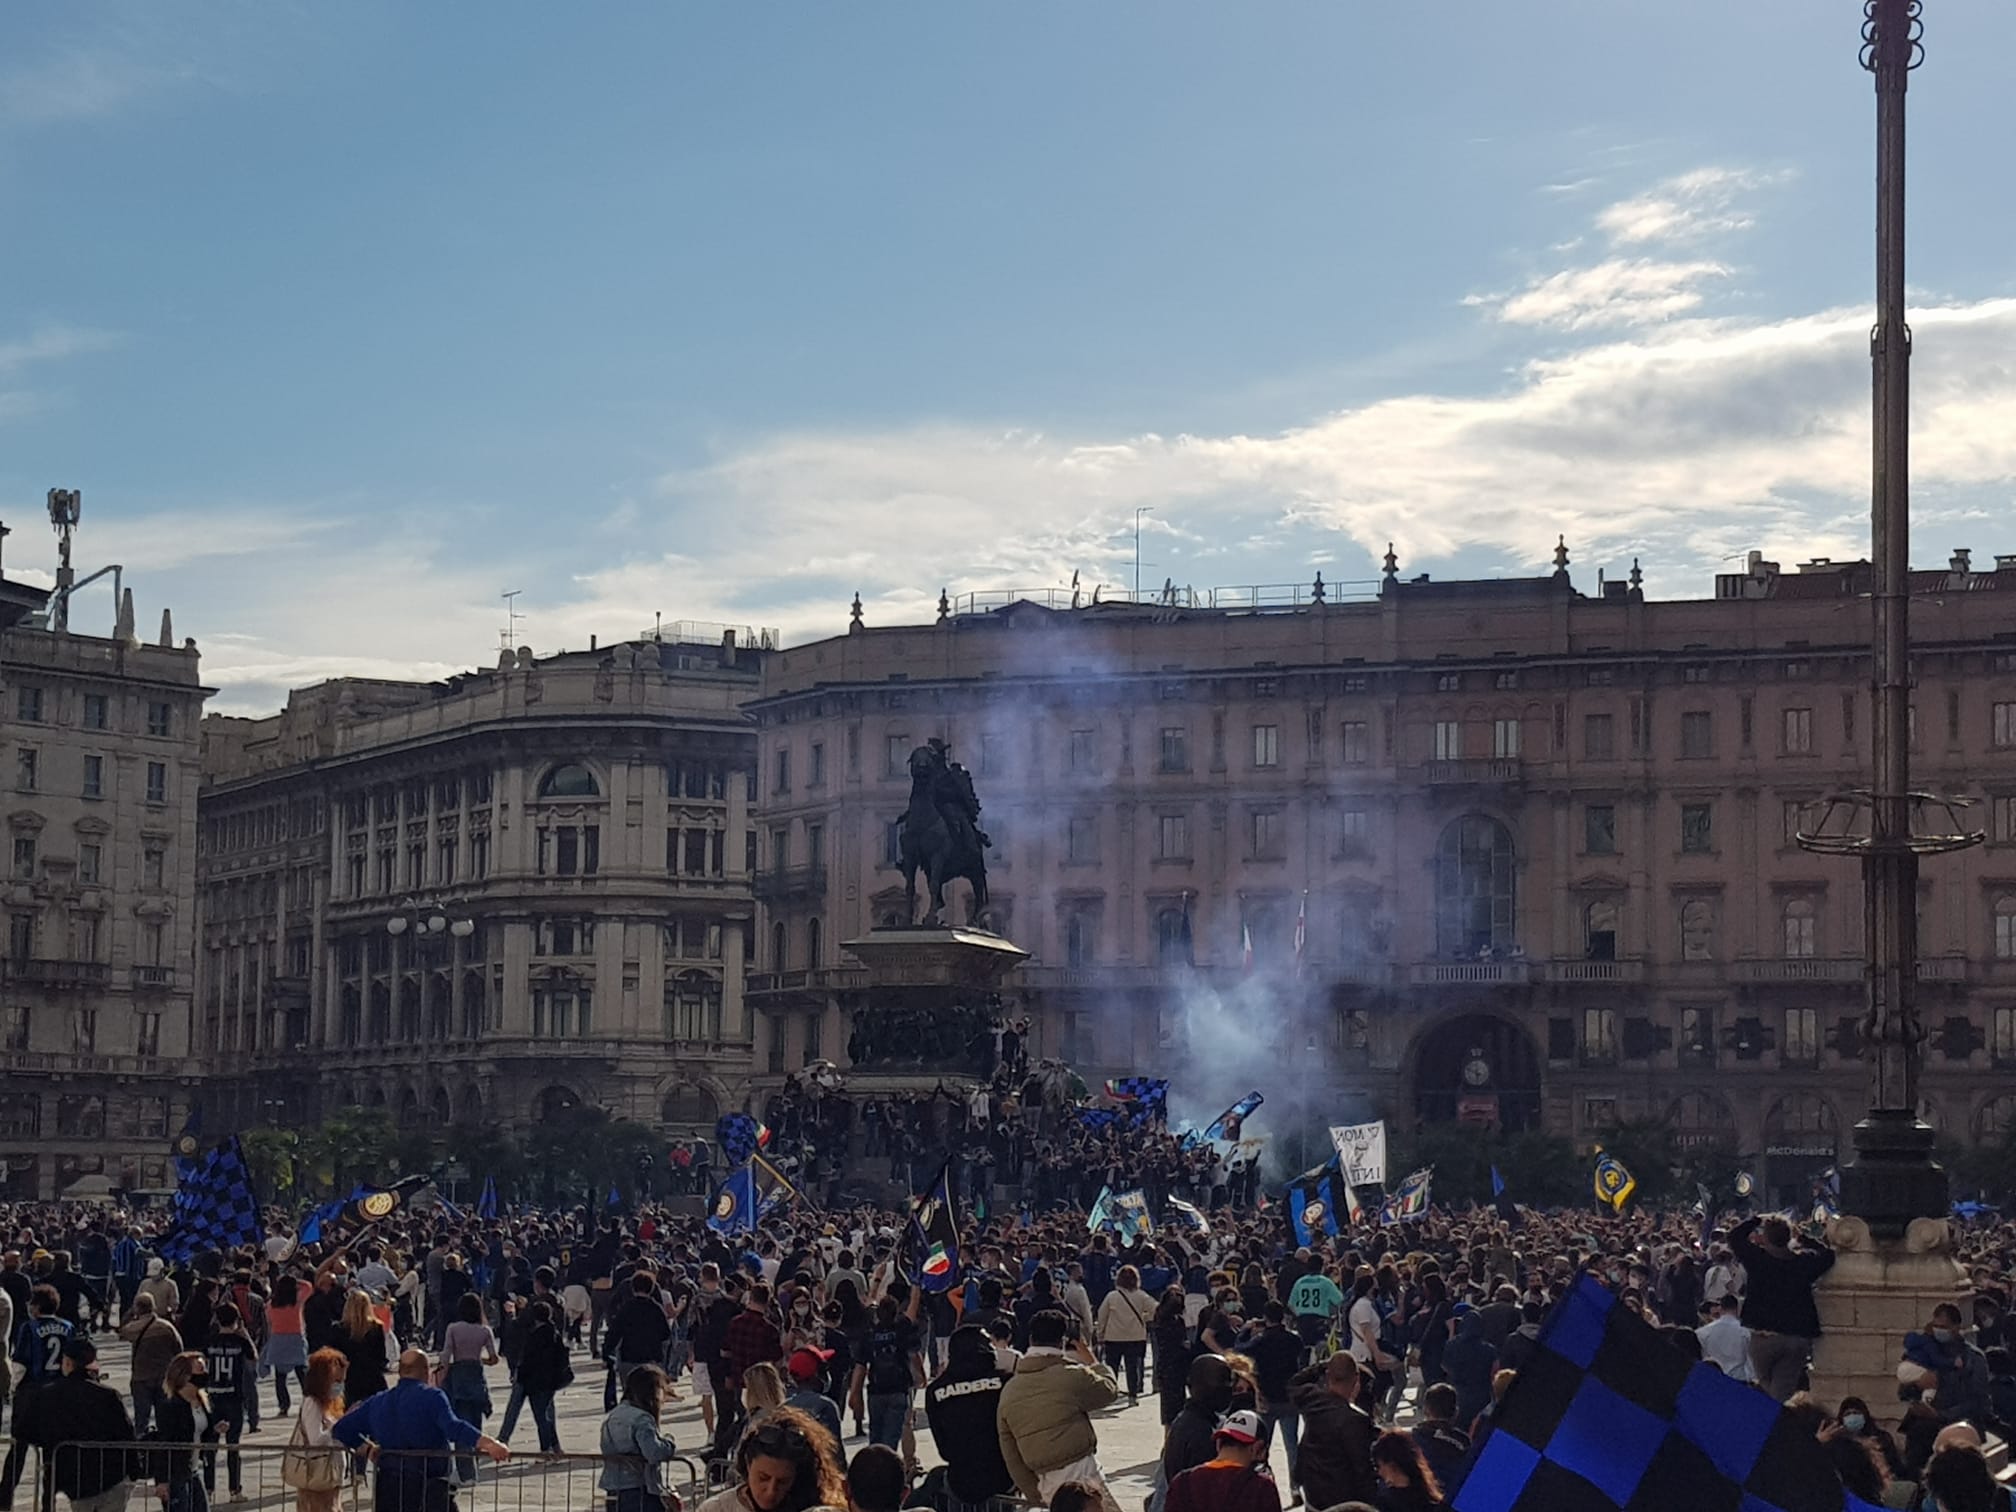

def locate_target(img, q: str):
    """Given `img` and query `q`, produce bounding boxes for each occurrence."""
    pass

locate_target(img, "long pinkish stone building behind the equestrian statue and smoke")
[752,550,2016,1195]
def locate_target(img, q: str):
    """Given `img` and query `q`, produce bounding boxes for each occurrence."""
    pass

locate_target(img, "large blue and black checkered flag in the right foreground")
[1452,1276,1875,1512]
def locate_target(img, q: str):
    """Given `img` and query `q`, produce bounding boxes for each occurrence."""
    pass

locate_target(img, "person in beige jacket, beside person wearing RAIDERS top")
[996,1312,1121,1512]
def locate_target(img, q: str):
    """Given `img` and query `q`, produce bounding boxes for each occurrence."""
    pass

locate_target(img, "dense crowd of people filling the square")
[0,1161,2016,1512]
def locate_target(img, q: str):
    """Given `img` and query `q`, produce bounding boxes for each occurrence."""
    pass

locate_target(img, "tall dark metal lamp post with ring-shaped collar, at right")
[1798,0,1982,1238]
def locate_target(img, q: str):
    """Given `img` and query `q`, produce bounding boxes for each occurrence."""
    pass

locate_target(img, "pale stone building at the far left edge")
[0,581,208,1200]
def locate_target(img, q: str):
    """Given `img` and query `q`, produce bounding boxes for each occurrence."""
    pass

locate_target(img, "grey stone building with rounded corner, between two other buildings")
[196,627,764,1133]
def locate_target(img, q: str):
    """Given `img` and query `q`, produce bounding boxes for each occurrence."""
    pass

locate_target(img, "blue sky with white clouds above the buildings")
[0,0,2016,714]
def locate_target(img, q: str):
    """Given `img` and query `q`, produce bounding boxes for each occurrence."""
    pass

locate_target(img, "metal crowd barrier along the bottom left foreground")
[20,1441,706,1512]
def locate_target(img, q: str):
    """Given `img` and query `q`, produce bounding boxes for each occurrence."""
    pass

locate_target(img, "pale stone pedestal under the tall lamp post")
[1812,1218,1972,1427]
